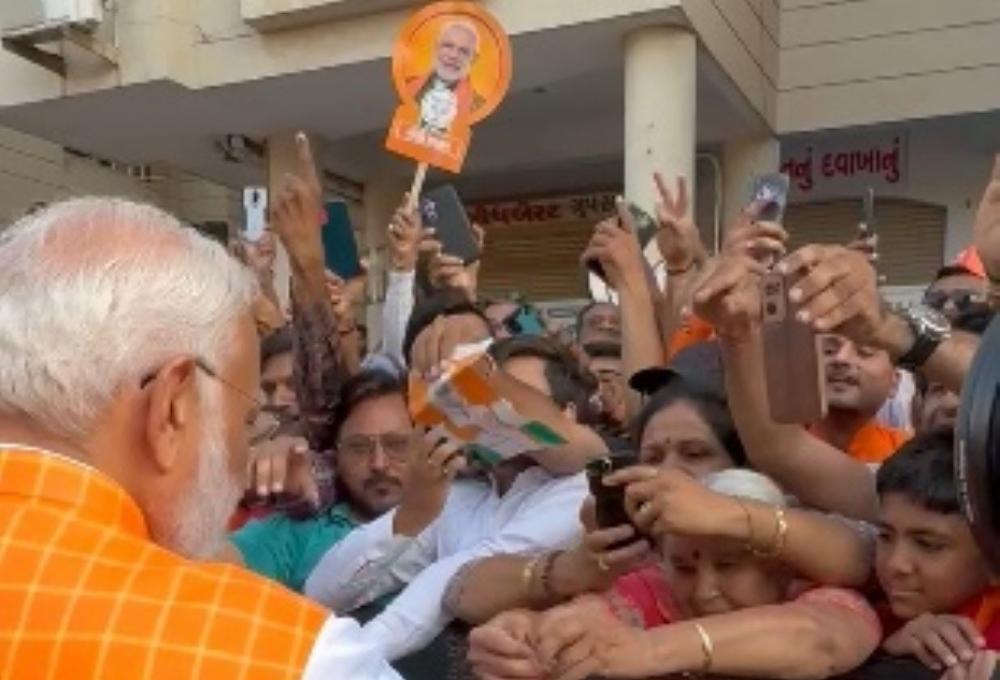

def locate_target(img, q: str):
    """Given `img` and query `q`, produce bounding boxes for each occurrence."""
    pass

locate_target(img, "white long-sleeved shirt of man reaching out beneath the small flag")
[305,467,587,660]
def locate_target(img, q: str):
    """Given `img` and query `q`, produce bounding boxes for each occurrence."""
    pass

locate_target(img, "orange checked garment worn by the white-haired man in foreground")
[0,447,329,680]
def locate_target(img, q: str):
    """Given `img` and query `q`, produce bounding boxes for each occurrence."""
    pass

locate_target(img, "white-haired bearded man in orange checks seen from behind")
[0,139,398,680]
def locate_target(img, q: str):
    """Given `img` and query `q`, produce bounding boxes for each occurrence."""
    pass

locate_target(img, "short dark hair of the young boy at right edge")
[875,428,962,515]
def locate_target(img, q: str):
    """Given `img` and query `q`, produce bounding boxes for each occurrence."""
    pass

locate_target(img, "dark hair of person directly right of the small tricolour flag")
[490,335,597,422]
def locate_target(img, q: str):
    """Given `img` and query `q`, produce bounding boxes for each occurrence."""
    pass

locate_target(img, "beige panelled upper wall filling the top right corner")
[780,0,1000,133]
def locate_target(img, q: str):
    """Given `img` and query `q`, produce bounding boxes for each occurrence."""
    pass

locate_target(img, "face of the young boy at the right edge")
[875,493,990,620]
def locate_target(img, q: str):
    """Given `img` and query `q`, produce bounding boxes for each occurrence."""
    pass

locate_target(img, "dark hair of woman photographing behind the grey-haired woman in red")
[632,375,747,467]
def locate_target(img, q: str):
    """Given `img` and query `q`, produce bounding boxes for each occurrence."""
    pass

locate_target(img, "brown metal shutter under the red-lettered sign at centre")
[479,220,593,302]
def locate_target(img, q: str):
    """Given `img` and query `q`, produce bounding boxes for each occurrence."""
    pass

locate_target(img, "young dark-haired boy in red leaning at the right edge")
[876,430,1000,677]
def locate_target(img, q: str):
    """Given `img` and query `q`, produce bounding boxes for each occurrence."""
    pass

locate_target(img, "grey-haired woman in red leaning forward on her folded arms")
[470,470,881,680]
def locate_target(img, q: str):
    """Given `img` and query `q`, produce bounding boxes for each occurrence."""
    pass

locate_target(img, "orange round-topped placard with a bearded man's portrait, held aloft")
[385,2,511,172]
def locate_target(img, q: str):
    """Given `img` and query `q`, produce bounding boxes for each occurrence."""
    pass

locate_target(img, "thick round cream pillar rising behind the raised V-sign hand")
[625,26,698,214]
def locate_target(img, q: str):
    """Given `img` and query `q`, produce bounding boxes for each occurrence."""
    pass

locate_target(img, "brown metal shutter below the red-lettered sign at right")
[785,198,947,286]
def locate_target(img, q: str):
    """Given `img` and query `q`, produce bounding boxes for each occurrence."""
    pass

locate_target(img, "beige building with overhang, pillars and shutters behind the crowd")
[0,0,1000,310]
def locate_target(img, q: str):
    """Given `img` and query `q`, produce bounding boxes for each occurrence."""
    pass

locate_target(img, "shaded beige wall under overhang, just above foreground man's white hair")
[0,128,242,228]
